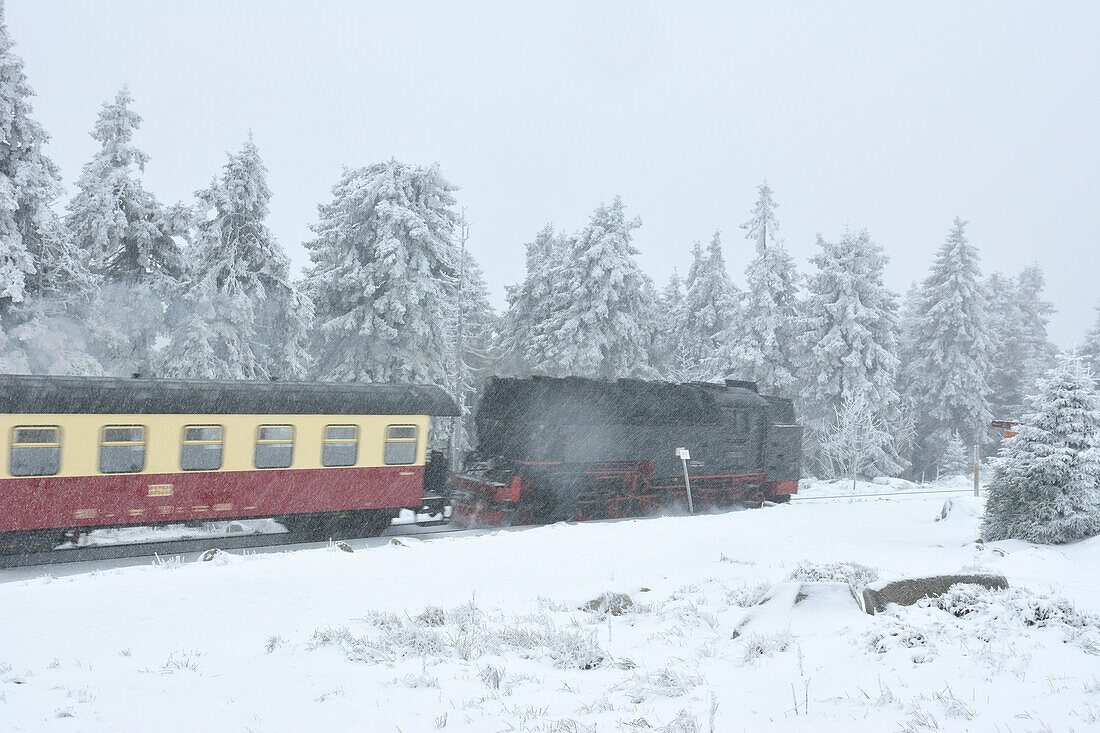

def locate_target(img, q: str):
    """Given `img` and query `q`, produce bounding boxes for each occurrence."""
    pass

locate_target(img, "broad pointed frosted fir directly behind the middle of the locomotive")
[546,196,657,379]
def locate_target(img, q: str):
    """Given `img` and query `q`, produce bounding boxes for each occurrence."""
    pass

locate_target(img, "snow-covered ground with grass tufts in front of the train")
[0,482,1100,733]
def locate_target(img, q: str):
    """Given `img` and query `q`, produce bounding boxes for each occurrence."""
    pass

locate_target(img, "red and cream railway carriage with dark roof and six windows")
[0,375,457,551]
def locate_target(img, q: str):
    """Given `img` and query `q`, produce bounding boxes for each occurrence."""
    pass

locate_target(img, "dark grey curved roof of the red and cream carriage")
[0,374,459,416]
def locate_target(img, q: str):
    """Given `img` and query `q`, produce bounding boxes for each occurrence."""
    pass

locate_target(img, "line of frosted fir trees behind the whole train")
[0,14,1100,477]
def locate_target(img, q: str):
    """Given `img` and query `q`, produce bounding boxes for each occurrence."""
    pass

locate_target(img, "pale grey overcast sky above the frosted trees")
[7,0,1100,346]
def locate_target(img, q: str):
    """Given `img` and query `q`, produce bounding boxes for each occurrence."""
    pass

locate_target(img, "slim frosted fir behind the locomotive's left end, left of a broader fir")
[498,223,570,375]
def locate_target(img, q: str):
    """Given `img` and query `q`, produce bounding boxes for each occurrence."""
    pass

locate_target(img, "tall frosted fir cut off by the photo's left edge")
[0,4,63,308]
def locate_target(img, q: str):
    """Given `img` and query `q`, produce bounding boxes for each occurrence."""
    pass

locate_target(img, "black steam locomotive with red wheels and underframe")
[451,376,802,525]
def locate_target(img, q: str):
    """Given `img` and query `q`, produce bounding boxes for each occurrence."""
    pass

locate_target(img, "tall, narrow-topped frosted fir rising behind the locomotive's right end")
[738,183,799,394]
